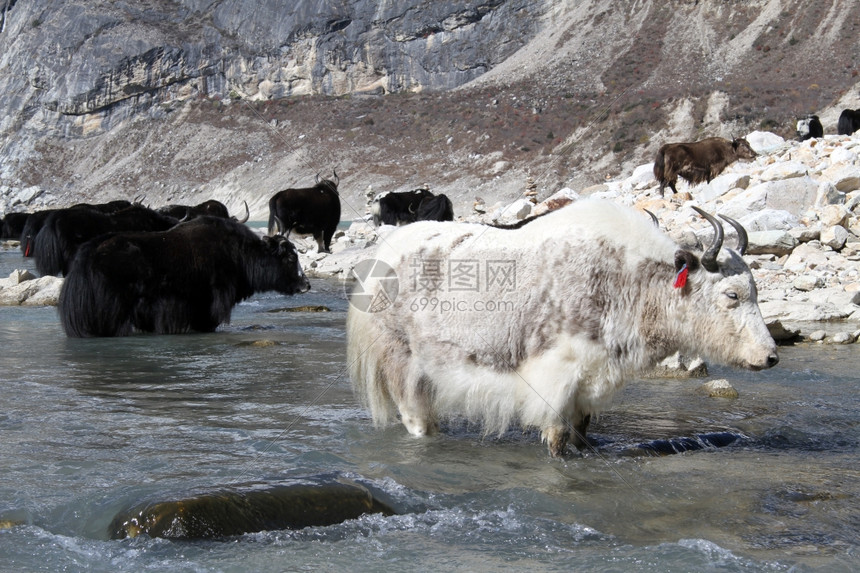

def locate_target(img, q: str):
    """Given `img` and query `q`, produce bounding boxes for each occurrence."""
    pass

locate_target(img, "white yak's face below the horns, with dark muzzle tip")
[683,249,779,370]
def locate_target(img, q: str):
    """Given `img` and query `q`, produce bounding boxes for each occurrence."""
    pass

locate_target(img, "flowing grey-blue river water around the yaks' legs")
[0,244,860,572]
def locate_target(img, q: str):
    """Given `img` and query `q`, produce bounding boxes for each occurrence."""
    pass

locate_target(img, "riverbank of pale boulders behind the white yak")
[5,132,860,343]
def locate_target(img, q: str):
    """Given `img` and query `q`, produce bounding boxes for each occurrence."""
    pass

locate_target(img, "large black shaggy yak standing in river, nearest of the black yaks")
[59,217,310,337]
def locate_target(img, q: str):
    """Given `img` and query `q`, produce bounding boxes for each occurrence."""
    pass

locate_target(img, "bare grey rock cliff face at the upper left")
[0,0,540,125]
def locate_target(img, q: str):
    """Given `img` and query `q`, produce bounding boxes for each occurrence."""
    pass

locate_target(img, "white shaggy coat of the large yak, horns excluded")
[347,200,775,455]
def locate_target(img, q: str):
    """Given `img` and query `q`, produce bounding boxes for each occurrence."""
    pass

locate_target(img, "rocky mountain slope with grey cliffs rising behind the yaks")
[0,0,860,219]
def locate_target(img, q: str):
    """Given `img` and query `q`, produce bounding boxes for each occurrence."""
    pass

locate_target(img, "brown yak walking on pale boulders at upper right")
[654,137,756,197]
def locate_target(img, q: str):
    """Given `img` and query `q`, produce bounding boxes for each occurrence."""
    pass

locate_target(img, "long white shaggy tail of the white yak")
[346,306,396,427]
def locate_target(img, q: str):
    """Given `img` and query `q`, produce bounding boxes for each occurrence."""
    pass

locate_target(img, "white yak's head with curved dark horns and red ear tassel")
[674,207,779,370]
